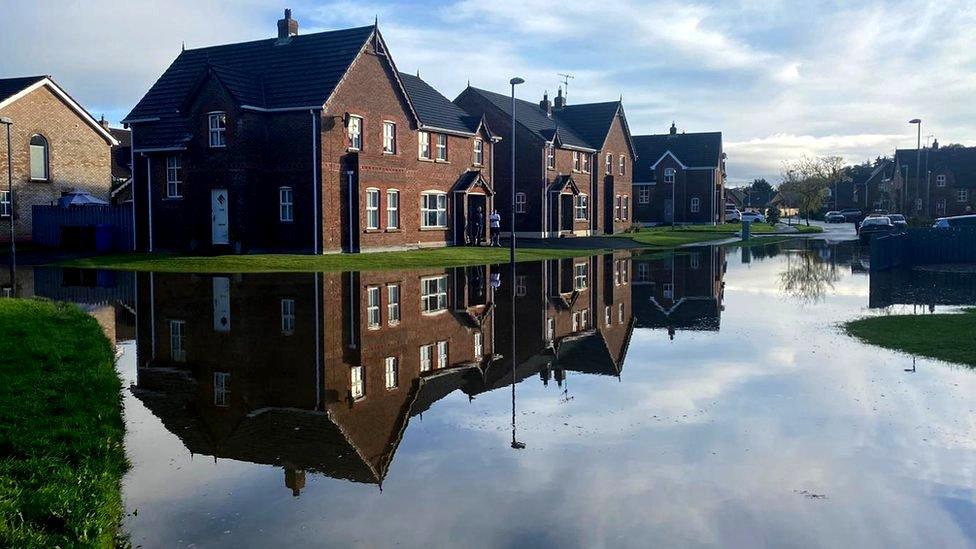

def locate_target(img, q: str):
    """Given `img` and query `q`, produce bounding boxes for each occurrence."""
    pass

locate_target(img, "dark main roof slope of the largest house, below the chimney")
[126,26,375,148]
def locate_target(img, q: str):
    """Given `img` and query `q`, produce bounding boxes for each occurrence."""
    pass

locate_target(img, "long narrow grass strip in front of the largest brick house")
[62,247,602,273]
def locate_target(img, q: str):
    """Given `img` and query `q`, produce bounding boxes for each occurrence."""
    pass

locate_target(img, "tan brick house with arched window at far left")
[0,76,118,241]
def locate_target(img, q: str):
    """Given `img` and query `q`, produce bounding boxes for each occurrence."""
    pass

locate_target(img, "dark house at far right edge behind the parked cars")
[890,140,976,218]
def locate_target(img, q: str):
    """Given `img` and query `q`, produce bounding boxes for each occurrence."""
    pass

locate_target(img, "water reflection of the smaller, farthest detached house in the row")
[632,246,726,337]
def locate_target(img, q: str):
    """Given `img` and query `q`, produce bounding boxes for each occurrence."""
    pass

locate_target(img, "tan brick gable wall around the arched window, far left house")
[0,86,112,241]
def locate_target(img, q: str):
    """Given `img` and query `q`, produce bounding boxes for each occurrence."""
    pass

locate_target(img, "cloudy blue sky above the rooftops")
[0,0,976,186]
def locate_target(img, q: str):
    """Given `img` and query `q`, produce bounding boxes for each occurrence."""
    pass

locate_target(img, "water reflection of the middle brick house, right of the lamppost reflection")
[464,252,632,396]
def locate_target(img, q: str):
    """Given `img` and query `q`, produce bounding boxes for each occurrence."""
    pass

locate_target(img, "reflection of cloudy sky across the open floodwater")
[122,244,976,547]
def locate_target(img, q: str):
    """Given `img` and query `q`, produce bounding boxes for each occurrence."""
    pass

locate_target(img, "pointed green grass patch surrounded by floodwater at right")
[844,309,976,367]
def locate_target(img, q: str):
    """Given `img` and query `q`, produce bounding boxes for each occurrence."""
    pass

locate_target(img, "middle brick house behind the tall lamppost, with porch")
[454,85,635,238]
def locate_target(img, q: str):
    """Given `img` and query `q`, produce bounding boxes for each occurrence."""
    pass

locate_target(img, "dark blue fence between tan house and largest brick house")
[31,204,133,252]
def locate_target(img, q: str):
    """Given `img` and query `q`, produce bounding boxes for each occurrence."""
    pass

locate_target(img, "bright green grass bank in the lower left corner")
[0,299,127,547]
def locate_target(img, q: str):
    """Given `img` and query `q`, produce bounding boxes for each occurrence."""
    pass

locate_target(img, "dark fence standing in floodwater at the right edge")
[871,227,976,271]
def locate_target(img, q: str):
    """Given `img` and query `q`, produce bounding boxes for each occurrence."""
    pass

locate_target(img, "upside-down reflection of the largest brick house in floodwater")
[134,266,494,488]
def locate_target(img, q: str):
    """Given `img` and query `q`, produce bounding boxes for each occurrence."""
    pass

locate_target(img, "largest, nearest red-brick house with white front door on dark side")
[124,10,495,253]
